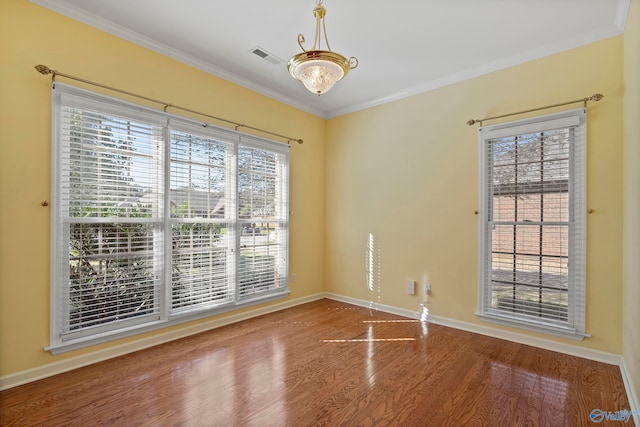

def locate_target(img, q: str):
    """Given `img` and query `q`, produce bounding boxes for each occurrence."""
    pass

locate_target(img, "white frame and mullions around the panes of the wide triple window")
[45,82,290,354]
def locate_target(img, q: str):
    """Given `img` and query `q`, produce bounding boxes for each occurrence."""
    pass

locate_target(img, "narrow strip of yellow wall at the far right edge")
[623,0,640,404]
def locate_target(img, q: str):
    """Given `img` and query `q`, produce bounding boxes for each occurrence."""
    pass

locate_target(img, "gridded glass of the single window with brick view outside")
[484,118,574,330]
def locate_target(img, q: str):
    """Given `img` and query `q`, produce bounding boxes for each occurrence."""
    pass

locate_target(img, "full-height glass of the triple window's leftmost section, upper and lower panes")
[60,106,160,334]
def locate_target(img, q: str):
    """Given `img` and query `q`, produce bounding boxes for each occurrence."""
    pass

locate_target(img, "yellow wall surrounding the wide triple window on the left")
[0,0,325,376]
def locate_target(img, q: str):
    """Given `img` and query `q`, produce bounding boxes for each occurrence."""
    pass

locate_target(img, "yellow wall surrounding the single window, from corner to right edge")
[325,36,623,354]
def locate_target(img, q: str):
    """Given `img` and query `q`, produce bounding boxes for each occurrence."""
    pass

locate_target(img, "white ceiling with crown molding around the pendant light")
[32,0,629,118]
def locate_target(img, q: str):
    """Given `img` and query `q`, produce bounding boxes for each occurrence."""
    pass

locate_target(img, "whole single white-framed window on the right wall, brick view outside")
[478,109,586,339]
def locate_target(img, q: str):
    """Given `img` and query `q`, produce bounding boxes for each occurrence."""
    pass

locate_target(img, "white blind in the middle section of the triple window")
[168,125,236,313]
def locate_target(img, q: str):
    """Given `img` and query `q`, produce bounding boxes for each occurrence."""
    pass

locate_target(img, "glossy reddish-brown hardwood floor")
[0,300,633,427]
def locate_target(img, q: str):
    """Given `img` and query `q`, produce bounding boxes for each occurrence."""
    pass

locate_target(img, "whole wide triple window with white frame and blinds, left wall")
[48,83,289,353]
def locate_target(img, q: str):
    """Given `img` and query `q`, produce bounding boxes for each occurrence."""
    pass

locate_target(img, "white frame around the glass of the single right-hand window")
[476,108,589,340]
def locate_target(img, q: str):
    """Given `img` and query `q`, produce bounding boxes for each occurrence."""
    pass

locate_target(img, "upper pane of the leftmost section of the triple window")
[63,107,159,221]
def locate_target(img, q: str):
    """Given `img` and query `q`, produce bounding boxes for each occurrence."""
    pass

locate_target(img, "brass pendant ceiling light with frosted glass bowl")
[287,0,358,96]
